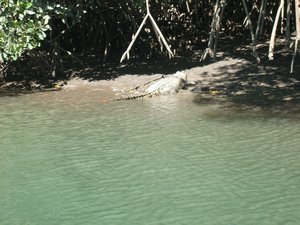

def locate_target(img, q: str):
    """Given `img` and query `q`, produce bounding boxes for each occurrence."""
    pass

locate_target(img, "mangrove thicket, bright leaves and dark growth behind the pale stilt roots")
[0,0,294,81]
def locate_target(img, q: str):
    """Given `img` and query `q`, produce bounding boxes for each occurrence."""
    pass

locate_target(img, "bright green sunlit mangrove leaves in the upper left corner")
[0,0,50,64]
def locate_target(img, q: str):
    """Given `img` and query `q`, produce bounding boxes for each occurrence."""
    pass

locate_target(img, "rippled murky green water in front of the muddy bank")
[0,92,300,225]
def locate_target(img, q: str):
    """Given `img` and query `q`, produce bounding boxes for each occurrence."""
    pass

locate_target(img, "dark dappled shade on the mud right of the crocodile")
[194,51,300,113]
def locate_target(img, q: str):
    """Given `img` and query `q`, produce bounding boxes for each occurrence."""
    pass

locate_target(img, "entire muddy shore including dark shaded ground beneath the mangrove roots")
[0,46,300,111]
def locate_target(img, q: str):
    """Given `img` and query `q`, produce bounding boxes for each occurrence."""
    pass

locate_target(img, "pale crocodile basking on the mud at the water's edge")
[114,71,187,100]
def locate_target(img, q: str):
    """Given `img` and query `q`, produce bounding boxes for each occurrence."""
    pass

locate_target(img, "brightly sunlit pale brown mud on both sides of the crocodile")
[62,58,250,95]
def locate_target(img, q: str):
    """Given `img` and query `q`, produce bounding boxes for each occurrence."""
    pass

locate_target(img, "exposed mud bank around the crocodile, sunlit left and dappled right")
[62,57,300,105]
